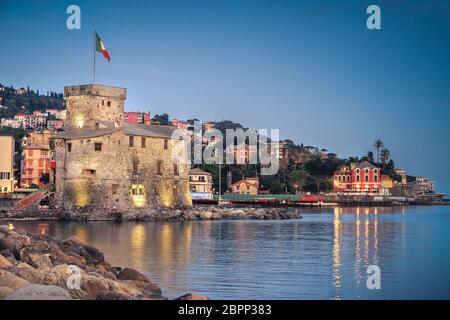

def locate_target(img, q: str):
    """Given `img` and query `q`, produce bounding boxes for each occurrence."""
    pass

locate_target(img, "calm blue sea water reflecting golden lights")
[4,207,450,299]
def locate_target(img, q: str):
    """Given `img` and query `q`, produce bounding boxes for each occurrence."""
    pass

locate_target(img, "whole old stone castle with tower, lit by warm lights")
[54,84,192,211]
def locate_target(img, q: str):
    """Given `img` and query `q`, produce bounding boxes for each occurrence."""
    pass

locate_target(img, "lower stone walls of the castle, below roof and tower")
[55,130,191,211]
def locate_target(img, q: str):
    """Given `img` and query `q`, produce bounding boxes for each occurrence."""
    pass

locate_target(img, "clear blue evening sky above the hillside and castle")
[0,0,450,193]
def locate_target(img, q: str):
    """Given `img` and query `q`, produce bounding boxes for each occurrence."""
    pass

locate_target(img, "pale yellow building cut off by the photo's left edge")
[0,136,14,193]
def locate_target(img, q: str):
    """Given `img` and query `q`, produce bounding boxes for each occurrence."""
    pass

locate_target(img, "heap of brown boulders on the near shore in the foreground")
[0,225,207,300]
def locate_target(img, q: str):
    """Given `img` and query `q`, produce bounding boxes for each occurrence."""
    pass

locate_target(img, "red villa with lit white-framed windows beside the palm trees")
[333,161,381,193]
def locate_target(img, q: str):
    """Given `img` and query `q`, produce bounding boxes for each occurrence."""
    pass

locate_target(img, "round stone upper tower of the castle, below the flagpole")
[64,84,127,128]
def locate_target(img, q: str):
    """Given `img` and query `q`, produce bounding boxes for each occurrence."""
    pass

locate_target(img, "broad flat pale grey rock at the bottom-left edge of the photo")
[5,284,71,300]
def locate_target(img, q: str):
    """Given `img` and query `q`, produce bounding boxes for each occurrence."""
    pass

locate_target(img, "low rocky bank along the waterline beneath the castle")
[0,206,301,221]
